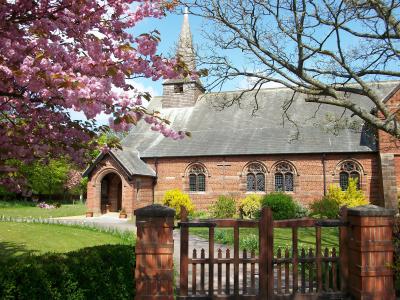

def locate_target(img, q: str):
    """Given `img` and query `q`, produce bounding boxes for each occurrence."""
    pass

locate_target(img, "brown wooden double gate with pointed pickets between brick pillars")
[177,208,348,300]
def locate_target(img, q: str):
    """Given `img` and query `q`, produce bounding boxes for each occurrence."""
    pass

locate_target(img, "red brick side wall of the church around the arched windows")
[147,153,380,209]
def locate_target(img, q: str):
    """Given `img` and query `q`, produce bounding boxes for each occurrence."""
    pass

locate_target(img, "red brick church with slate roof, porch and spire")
[84,10,400,214]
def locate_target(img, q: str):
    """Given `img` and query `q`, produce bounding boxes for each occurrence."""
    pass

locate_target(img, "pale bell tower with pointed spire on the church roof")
[162,8,205,108]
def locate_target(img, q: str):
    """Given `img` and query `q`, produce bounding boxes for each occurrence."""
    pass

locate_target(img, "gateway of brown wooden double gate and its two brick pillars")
[135,204,396,300]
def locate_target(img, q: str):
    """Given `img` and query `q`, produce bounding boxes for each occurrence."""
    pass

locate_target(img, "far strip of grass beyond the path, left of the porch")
[0,201,86,218]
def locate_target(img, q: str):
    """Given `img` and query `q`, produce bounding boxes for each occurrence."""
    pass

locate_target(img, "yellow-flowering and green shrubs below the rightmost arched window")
[311,178,368,218]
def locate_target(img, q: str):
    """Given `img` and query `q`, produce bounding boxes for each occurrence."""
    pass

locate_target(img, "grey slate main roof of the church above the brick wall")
[120,81,399,162]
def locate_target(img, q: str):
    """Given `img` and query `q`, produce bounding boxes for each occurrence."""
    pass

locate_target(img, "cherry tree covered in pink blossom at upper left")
[0,0,195,190]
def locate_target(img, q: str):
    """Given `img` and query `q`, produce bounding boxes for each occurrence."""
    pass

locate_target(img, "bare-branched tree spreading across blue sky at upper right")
[186,0,400,140]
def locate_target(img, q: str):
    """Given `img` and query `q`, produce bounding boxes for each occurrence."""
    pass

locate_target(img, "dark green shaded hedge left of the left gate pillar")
[0,243,135,299]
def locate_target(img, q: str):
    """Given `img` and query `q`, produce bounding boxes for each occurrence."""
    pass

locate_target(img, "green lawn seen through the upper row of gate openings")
[190,228,339,250]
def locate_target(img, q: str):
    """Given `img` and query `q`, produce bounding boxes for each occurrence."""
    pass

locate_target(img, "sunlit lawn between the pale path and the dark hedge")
[0,222,134,260]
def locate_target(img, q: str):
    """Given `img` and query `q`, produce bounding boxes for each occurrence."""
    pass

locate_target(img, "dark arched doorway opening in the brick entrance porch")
[100,173,122,214]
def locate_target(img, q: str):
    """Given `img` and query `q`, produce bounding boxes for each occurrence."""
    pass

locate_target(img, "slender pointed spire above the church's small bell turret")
[176,7,196,71]
